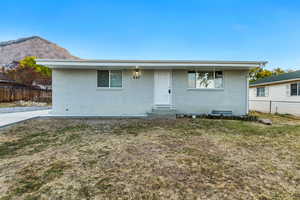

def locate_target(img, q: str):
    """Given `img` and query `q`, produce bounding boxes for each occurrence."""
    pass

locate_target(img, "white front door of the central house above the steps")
[154,70,172,105]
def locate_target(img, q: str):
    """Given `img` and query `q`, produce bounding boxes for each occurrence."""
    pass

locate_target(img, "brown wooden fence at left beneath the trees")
[0,86,52,103]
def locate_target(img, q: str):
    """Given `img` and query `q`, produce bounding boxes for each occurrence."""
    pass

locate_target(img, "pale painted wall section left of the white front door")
[52,69,154,116]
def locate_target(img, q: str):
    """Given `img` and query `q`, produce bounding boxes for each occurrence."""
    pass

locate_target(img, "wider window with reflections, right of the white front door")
[188,71,223,89]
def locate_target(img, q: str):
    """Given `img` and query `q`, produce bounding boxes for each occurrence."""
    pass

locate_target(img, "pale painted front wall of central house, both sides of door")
[52,69,248,116]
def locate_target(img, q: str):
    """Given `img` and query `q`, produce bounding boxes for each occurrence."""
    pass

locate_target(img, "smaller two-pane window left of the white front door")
[97,70,122,88]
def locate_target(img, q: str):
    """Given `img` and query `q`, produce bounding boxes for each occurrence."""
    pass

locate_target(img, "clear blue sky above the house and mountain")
[0,0,300,69]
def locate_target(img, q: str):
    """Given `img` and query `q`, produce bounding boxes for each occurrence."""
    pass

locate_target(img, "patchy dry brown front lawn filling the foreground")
[0,116,300,200]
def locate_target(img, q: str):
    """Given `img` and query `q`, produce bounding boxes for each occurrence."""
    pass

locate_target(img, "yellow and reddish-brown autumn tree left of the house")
[7,56,52,86]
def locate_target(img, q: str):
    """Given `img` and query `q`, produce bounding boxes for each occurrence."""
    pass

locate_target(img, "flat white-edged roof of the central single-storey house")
[36,59,267,70]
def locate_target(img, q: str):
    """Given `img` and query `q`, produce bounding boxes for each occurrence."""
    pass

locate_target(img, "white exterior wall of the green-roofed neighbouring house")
[249,83,300,116]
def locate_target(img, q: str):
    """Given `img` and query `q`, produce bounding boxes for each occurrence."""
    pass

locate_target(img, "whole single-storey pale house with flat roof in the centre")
[36,59,266,117]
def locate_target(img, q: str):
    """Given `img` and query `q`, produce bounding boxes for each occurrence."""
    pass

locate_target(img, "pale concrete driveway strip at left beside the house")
[0,110,50,128]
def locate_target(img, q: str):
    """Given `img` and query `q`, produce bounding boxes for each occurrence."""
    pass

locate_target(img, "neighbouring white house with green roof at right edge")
[249,70,300,115]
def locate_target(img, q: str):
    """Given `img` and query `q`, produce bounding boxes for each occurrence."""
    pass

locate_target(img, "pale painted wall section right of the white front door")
[173,70,248,115]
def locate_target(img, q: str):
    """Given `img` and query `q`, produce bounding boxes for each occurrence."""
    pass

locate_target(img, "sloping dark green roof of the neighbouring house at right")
[250,70,300,86]
